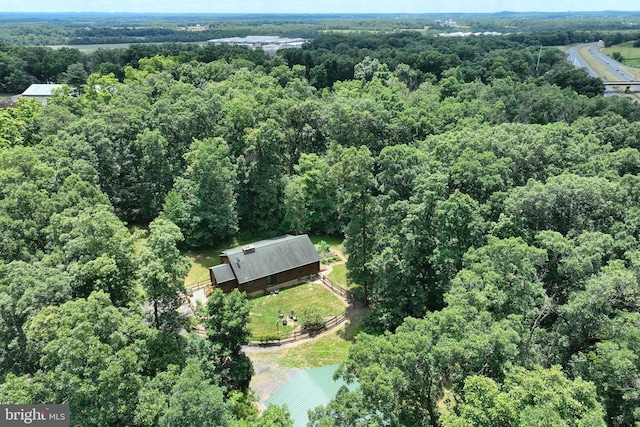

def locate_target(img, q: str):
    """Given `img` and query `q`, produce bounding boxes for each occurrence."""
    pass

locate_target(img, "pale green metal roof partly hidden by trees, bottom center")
[265,365,357,427]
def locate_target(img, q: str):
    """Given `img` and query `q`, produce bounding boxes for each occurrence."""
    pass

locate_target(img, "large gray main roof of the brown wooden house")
[216,234,320,284]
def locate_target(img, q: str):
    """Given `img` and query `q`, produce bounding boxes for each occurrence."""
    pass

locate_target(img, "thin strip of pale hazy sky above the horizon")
[0,0,640,13]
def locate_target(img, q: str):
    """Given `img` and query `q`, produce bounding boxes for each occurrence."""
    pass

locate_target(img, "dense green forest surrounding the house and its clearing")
[0,20,640,426]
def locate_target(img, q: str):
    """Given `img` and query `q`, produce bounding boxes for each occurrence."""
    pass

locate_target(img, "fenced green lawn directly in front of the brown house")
[249,283,345,337]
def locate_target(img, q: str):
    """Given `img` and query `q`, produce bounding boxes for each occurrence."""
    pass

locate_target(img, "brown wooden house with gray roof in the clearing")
[209,234,320,294]
